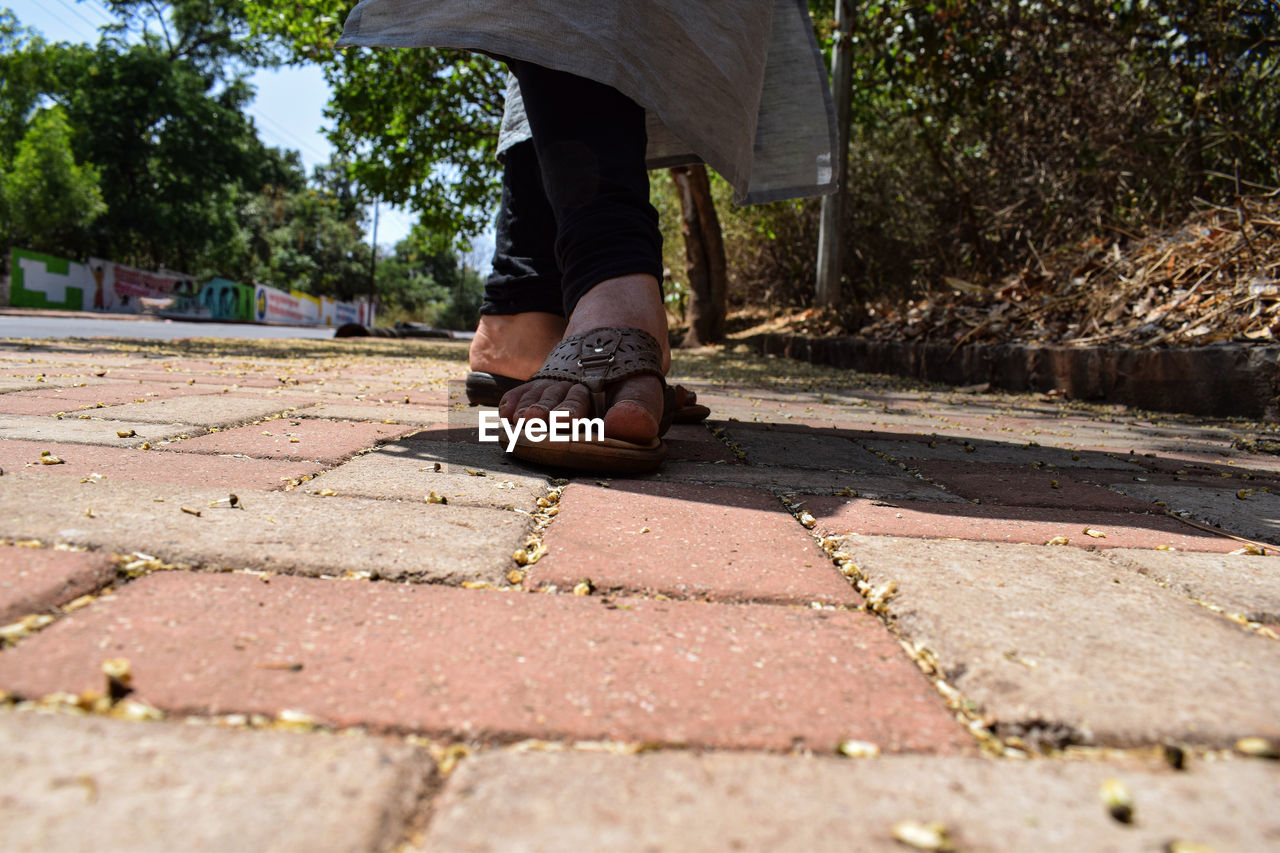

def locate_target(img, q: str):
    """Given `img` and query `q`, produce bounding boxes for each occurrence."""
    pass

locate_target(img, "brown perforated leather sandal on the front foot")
[512,328,676,474]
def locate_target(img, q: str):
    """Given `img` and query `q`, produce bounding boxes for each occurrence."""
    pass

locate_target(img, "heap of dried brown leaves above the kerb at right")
[814,191,1280,348]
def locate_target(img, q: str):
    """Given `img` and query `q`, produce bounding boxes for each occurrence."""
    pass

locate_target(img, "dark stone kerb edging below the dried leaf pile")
[745,333,1280,420]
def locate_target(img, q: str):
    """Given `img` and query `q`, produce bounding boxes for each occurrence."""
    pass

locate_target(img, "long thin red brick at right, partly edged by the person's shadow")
[800,497,1240,553]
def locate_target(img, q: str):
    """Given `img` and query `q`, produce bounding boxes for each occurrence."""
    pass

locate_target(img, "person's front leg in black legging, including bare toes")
[500,63,669,442]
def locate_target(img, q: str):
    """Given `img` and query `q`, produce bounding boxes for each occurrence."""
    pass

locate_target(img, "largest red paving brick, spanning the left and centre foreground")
[0,573,972,752]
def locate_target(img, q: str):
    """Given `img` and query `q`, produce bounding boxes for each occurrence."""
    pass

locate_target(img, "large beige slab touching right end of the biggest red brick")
[844,537,1280,747]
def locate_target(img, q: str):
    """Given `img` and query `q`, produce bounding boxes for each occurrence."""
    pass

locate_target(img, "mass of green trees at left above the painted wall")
[0,0,481,328]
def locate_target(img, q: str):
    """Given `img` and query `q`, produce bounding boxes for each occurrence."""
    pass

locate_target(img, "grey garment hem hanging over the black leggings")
[339,0,835,204]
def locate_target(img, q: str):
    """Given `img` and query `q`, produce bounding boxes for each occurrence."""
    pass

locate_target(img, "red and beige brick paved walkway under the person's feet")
[0,341,1280,852]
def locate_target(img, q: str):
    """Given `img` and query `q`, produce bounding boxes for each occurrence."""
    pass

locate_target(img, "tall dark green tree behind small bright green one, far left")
[0,0,294,275]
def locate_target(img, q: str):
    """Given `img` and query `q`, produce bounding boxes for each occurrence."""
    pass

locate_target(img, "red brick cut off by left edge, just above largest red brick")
[0,546,115,625]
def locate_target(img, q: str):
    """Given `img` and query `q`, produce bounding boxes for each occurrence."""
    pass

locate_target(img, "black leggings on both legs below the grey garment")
[480,61,662,316]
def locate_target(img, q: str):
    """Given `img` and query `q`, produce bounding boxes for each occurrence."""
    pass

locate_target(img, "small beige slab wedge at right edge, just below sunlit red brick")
[1110,548,1280,625]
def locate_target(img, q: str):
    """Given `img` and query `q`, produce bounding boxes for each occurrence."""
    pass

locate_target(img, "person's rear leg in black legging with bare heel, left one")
[468,142,566,379]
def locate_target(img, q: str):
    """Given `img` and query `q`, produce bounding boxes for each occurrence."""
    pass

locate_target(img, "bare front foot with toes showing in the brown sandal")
[496,275,671,444]
